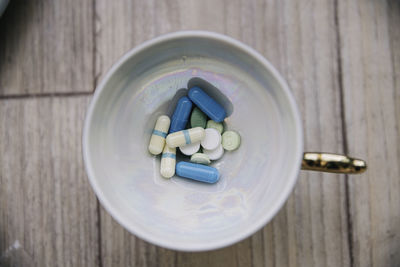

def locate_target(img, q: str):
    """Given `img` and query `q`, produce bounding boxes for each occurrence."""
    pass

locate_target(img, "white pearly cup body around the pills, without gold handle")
[84,32,302,251]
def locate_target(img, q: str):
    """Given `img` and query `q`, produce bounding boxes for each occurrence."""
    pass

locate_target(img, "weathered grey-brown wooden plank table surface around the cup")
[0,0,400,267]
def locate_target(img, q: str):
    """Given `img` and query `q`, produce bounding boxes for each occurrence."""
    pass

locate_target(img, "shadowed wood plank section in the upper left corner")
[0,0,94,96]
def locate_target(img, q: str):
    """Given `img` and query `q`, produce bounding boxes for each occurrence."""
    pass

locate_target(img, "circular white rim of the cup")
[82,30,303,251]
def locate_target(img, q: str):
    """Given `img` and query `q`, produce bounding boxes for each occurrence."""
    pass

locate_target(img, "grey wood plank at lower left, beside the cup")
[0,96,99,266]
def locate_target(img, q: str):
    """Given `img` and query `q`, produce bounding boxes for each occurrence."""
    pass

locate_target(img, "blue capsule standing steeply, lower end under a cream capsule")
[169,96,193,133]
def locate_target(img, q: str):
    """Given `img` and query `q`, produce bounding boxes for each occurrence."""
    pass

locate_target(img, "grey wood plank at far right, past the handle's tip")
[339,0,400,266]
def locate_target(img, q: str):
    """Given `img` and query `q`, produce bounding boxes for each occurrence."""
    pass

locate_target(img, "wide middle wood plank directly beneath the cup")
[96,0,350,266]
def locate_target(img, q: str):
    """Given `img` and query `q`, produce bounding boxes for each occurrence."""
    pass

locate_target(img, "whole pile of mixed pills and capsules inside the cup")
[149,87,240,183]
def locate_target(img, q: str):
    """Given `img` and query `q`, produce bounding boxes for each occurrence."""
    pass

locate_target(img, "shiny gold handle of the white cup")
[301,152,367,174]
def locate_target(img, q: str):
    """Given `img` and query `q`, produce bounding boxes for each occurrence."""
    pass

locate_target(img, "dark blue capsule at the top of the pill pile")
[189,86,226,122]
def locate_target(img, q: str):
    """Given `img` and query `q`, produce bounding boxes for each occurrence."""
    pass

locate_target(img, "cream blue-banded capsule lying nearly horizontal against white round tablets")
[166,127,205,147]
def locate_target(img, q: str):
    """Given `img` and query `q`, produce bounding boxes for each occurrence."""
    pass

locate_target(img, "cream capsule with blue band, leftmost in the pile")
[149,115,170,155]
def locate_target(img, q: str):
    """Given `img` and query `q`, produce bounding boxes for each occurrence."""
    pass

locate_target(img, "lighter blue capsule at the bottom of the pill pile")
[176,161,219,184]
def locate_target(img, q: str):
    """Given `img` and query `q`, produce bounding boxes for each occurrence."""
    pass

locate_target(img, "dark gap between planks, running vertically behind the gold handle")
[334,0,354,266]
